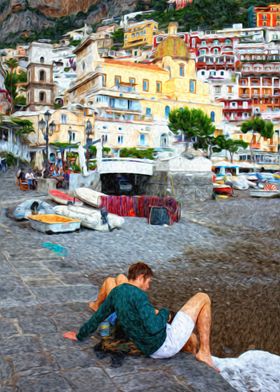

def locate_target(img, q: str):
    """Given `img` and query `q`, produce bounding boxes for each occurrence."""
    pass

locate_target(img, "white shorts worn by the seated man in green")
[150,311,194,359]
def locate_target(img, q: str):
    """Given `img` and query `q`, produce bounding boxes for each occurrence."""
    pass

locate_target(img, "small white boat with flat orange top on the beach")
[28,214,81,234]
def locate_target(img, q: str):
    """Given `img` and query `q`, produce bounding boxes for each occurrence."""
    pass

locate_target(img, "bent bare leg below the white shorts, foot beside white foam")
[180,293,214,367]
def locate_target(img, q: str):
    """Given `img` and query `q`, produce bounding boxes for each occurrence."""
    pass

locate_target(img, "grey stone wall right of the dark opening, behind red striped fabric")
[146,171,213,205]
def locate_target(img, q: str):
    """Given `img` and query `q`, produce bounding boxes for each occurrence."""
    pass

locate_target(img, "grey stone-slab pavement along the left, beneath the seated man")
[0,174,233,392]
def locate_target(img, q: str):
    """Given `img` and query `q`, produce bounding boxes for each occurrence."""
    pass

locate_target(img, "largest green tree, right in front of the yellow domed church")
[168,107,216,158]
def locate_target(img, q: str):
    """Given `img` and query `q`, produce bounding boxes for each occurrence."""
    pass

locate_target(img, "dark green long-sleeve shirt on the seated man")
[77,283,169,355]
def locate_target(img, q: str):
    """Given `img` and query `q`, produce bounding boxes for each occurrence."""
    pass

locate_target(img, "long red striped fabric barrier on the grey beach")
[100,195,181,223]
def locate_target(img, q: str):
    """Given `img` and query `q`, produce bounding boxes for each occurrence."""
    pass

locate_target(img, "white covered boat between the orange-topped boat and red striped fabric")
[54,205,124,231]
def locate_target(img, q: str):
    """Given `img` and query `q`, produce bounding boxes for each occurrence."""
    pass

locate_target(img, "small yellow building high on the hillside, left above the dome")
[123,20,158,49]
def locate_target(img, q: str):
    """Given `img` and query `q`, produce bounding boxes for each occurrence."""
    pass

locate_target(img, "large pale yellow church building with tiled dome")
[65,24,222,152]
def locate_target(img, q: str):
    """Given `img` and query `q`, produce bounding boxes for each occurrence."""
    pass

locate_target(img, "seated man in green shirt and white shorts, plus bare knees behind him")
[64,262,217,367]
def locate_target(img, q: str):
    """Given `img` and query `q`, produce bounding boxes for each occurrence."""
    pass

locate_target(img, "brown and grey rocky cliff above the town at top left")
[0,0,142,44]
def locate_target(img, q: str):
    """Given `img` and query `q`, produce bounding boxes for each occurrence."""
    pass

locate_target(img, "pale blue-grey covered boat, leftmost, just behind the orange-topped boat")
[13,199,54,220]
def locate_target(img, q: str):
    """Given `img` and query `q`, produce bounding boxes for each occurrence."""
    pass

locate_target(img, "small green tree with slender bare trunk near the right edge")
[241,116,274,161]
